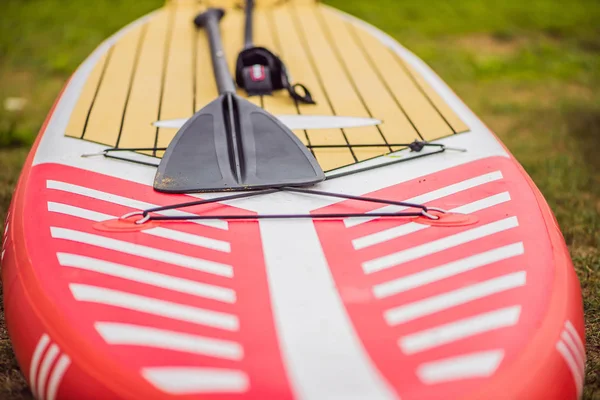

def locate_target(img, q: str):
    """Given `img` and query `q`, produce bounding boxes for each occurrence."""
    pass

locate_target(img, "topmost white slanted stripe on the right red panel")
[344,171,502,228]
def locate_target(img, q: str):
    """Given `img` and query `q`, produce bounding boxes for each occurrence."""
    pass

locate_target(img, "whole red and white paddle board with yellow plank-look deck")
[2,0,585,400]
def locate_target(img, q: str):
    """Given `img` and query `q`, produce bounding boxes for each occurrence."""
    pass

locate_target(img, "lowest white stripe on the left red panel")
[142,367,250,395]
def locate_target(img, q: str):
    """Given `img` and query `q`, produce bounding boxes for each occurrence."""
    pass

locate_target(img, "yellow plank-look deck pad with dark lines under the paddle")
[65,0,468,170]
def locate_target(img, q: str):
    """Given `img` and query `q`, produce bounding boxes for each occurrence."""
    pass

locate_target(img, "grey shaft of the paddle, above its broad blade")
[194,8,235,94]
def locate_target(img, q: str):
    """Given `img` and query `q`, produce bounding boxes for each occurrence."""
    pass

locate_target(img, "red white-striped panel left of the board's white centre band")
[4,164,291,399]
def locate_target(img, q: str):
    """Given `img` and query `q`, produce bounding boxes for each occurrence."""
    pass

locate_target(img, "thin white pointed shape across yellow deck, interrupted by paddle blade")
[152,115,381,130]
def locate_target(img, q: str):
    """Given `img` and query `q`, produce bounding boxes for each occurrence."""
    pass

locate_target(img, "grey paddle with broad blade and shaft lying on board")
[154,8,325,193]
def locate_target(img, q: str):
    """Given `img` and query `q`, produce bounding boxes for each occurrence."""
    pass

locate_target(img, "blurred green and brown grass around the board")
[0,0,600,399]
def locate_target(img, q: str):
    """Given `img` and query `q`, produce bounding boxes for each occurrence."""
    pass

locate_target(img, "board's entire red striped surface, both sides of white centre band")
[3,157,585,399]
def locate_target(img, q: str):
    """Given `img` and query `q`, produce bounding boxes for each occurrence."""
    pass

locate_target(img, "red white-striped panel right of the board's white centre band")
[314,157,576,399]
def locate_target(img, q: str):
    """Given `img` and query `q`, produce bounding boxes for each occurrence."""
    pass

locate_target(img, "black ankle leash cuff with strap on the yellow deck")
[235,0,315,104]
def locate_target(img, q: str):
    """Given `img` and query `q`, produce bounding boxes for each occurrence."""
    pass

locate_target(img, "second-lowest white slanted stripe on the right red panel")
[398,306,521,355]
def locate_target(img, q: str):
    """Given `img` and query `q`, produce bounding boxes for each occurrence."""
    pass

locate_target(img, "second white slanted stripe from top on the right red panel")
[352,192,510,250]
